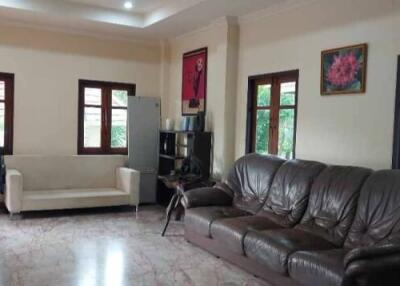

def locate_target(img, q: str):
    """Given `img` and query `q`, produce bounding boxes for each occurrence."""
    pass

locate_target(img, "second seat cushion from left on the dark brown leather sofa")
[210,215,282,254]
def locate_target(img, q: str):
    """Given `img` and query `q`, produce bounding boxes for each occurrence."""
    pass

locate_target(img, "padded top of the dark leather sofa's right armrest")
[343,243,400,268]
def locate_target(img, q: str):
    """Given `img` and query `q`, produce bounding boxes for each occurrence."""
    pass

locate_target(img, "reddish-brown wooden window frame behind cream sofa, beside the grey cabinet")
[78,79,136,155]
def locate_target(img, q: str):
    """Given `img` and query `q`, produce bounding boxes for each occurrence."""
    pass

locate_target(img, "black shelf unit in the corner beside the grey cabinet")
[157,130,212,204]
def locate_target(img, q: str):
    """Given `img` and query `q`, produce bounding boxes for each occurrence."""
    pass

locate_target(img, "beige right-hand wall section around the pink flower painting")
[235,0,400,168]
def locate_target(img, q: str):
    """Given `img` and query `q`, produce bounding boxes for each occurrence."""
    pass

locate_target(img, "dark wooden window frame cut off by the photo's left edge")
[0,73,15,155]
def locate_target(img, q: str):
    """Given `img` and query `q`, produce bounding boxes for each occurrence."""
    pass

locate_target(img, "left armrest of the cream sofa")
[5,169,23,214]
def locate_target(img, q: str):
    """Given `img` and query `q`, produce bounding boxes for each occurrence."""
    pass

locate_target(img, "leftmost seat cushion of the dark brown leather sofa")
[185,206,250,237]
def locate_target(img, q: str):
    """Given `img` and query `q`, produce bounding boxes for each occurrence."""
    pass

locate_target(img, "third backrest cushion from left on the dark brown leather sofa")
[296,166,371,246]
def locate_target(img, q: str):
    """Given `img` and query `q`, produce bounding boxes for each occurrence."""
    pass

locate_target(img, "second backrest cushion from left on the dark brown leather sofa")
[258,160,326,227]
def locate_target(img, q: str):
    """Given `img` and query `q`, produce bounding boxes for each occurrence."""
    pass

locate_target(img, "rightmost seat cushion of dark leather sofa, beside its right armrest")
[289,249,347,286]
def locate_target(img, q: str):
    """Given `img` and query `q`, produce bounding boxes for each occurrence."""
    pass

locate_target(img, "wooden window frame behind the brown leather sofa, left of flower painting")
[245,70,299,158]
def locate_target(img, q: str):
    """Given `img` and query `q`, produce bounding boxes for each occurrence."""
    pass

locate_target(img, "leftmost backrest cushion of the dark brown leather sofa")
[226,154,285,213]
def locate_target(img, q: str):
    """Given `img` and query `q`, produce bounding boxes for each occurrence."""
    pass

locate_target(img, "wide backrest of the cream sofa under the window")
[5,155,127,191]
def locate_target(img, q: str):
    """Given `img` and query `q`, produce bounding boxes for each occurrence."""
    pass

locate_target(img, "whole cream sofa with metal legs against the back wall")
[5,155,140,214]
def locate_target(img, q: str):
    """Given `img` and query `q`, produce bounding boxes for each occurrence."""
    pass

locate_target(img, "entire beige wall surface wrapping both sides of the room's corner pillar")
[0,0,400,174]
